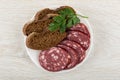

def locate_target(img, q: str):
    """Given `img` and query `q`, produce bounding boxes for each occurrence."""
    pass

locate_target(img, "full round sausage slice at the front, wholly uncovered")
[39,47,70,72]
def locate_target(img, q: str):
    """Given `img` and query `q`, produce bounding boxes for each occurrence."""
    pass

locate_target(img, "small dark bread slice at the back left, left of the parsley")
[35,8,57,20]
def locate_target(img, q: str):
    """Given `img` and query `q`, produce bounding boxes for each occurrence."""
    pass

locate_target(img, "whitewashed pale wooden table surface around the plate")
[0,0,120,80]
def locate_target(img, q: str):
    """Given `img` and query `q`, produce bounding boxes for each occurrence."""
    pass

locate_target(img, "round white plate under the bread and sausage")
[24,7,93,72]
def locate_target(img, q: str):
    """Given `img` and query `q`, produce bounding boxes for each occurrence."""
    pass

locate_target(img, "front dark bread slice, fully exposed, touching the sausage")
[26,31,66,50]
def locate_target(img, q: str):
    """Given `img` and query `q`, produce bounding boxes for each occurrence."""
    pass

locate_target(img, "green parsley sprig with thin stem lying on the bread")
[48,8,87,33]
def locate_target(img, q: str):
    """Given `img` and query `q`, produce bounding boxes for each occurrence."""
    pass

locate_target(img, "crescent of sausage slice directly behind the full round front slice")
[58,44,79,69]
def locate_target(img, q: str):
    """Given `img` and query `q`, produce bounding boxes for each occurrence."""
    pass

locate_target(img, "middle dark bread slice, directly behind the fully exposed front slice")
[23,19,53,36]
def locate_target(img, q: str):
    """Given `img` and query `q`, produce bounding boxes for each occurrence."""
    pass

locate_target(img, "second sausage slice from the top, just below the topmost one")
[67,31,90,50]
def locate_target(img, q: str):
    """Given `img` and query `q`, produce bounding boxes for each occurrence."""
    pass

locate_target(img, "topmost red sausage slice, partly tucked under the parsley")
[70,23,90,37]
